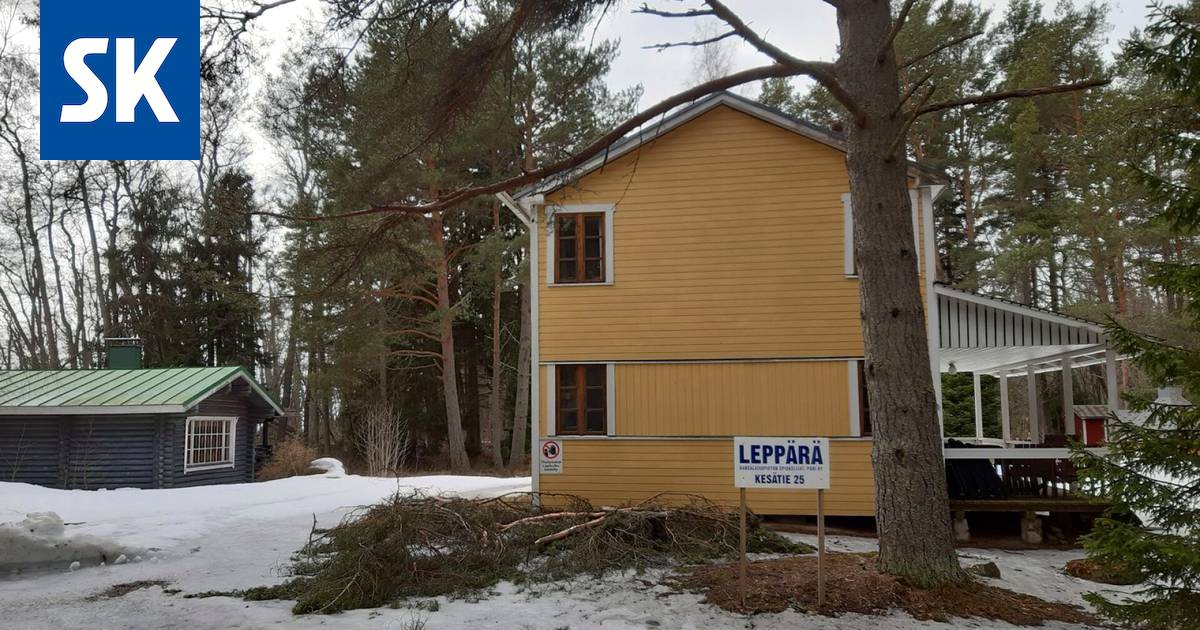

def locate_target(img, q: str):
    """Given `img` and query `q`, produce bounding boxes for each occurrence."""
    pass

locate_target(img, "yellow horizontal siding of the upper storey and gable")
[539,107,863,361]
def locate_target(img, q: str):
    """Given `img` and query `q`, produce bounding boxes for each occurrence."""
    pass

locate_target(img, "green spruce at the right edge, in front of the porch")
[1074,0,1200,628]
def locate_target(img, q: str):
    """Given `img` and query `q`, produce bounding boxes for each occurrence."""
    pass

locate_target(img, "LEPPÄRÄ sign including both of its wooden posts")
[733,437,829,607]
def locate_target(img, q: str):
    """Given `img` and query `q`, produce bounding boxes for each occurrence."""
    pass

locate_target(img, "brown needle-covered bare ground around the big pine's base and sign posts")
[672,553,1100,625]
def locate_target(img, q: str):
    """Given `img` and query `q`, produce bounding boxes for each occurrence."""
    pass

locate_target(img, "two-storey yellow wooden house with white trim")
[500,94,1123,516]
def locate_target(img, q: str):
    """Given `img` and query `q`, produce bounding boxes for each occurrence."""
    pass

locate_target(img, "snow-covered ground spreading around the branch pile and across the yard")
[0,475,1132,630]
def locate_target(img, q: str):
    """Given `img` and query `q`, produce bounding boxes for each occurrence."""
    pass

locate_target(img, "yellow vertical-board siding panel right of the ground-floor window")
[614,361,850,436]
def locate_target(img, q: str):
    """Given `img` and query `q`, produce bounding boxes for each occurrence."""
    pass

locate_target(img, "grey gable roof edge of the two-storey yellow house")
[514,91,947,199]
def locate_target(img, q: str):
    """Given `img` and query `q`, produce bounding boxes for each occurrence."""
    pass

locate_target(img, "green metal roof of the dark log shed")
[0,366,283,415]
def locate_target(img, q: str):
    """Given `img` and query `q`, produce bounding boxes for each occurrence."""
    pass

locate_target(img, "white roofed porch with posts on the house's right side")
[930,284,1121,525]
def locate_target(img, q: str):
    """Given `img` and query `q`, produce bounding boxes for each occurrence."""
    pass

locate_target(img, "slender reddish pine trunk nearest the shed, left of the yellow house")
[430,212,470,470]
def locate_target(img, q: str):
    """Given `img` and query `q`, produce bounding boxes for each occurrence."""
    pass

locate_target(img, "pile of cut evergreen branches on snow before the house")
[241,493,812,614]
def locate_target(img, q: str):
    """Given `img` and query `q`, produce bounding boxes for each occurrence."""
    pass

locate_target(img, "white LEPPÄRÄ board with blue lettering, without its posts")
[733,438,829,490]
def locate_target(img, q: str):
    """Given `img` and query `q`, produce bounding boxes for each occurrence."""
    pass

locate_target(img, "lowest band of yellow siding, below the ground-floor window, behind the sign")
[539,438,875,516]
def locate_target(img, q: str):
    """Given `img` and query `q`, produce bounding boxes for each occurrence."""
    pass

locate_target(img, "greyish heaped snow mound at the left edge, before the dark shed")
[0,512,134,572]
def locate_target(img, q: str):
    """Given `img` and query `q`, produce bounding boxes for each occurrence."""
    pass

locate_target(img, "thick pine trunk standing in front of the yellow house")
[836,0,962,584]
